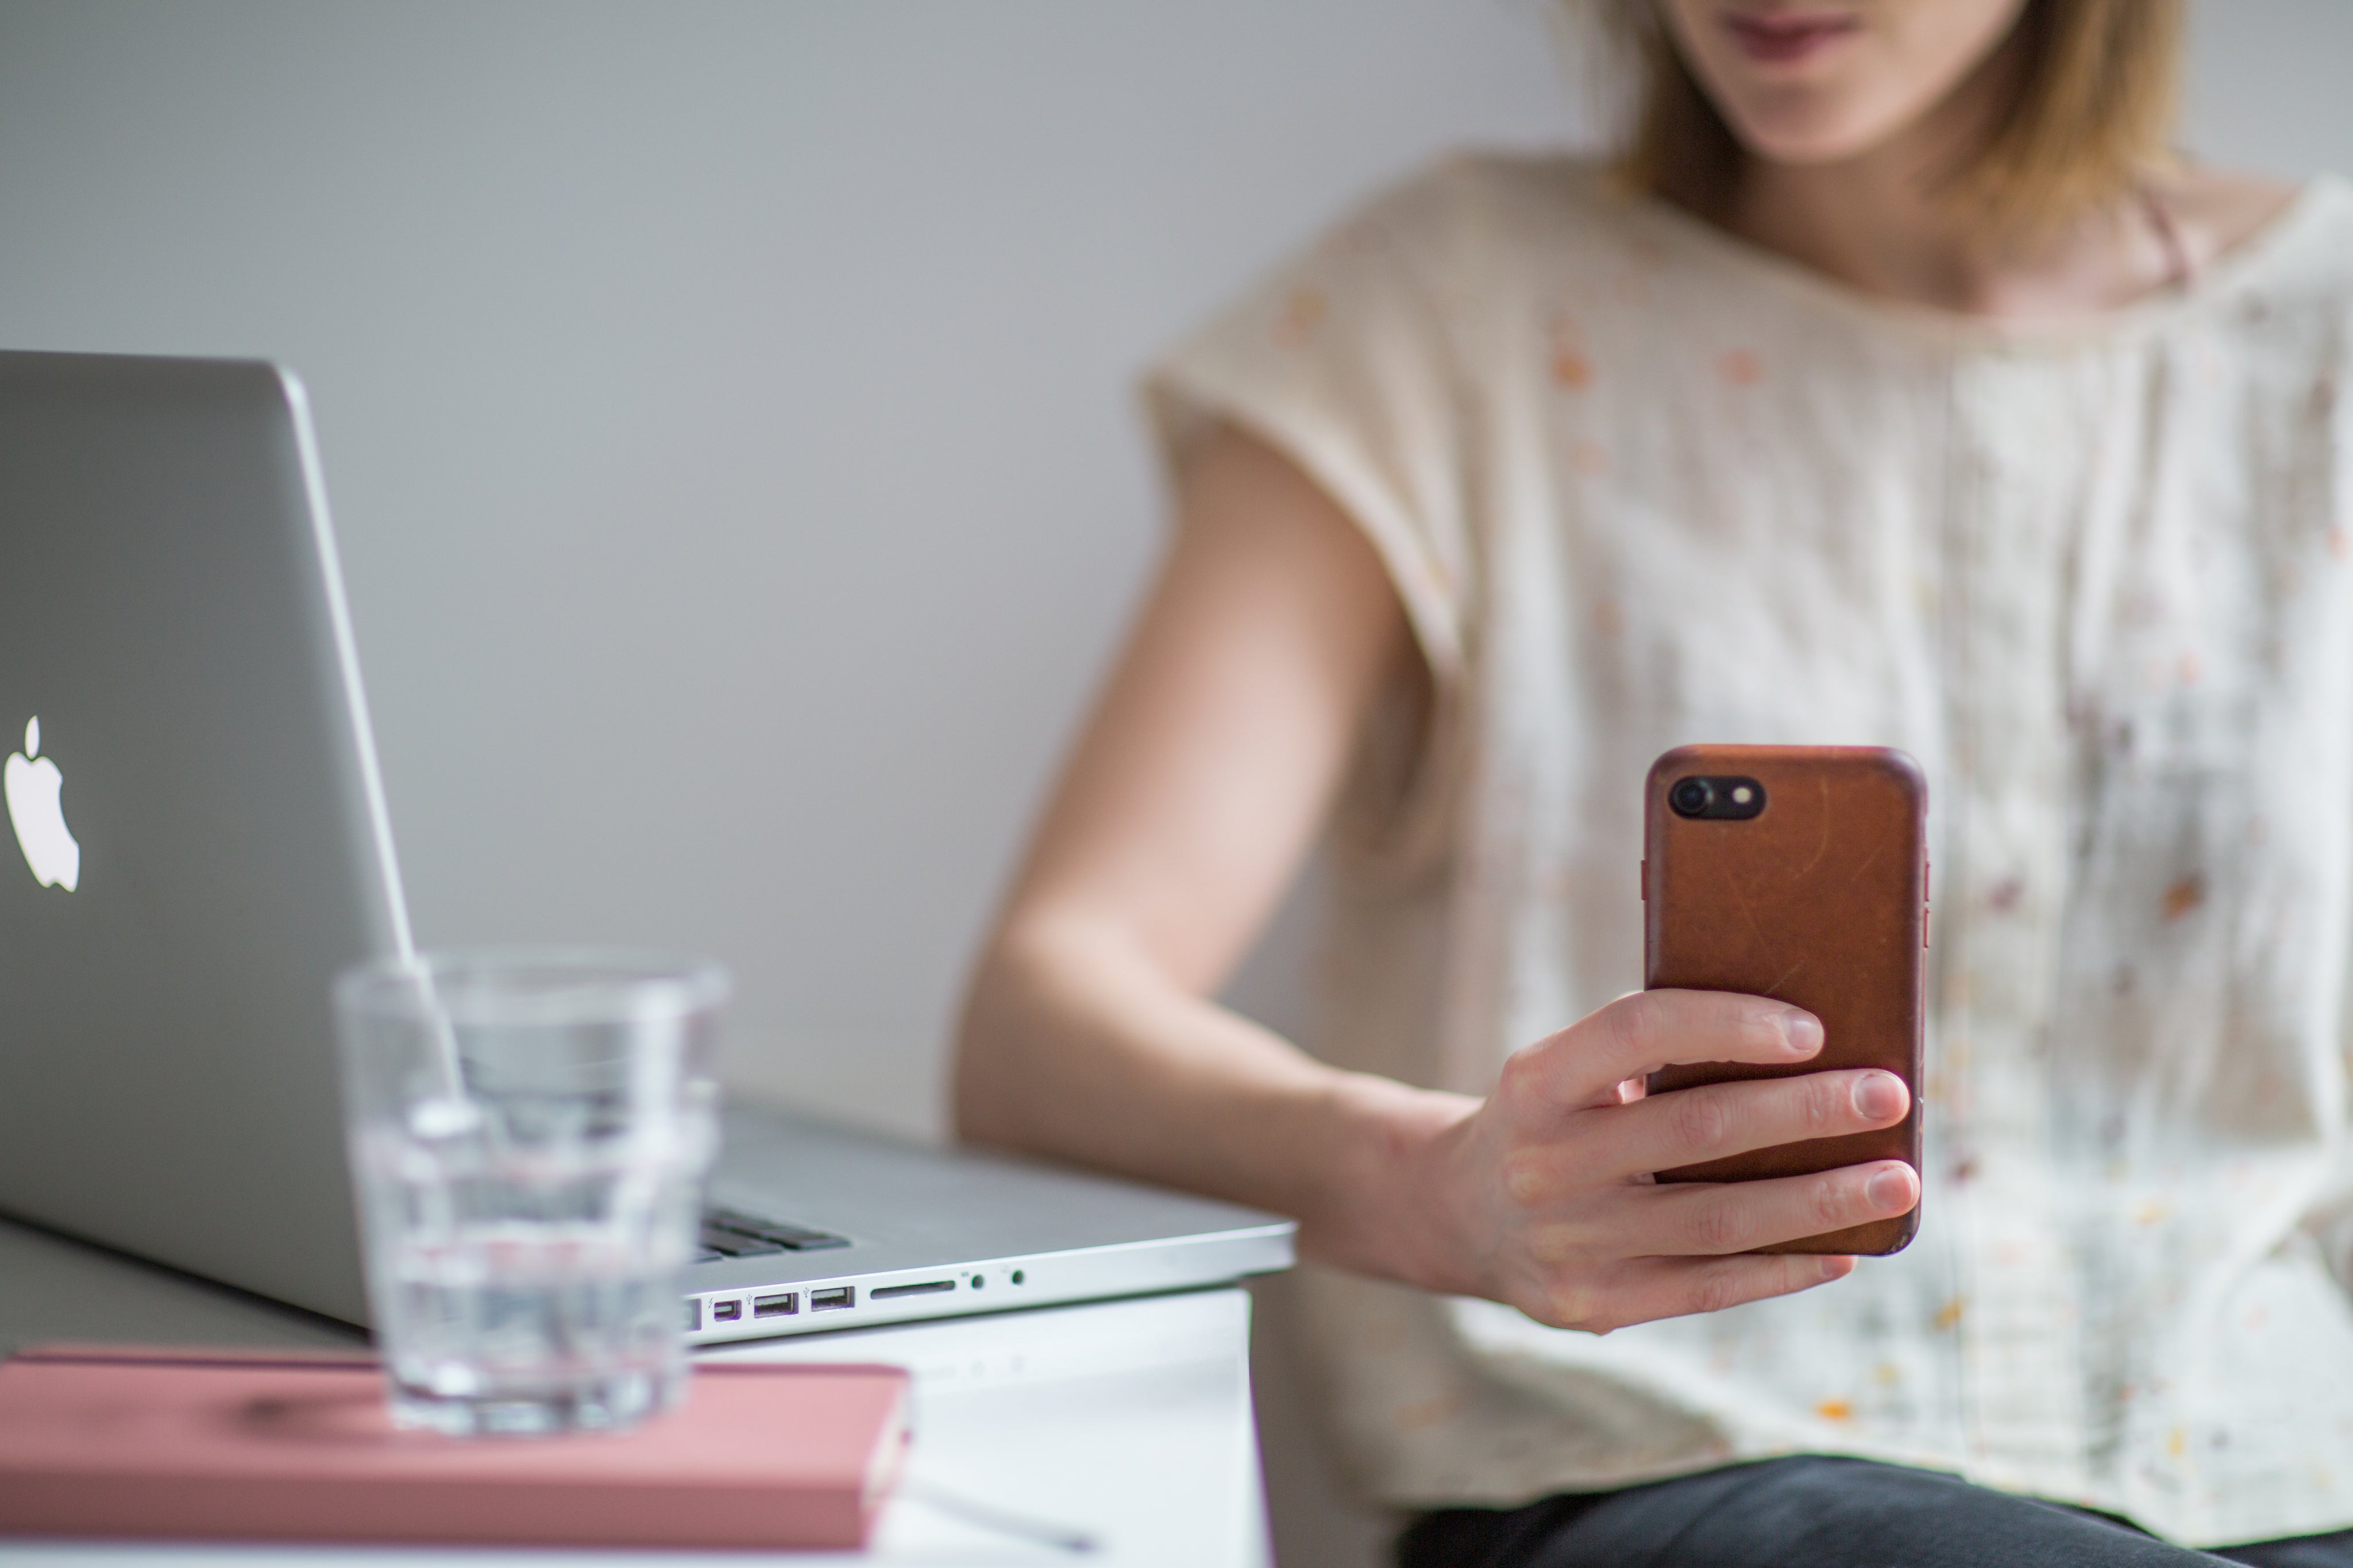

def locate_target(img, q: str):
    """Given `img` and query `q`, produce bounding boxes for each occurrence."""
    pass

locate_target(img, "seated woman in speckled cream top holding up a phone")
[955,0,2353,1566]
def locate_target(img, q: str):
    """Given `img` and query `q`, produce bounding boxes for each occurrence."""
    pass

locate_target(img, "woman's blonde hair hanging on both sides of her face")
[1567,0,2184,240]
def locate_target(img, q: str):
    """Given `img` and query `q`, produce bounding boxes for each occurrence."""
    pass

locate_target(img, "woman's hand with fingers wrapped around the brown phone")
[1402,990,1920,1333]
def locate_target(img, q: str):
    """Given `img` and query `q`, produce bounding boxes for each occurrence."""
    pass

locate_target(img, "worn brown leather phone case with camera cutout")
[1642,745,1927,1253]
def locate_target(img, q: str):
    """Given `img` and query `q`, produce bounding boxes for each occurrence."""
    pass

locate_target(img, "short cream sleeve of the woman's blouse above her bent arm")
[1144,176,1473,708]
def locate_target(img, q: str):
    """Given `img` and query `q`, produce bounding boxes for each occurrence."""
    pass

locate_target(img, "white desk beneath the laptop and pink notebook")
[0,1220,1266,1568]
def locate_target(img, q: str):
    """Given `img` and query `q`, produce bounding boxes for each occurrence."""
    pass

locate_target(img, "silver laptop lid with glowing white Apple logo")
[0,353,407,1321]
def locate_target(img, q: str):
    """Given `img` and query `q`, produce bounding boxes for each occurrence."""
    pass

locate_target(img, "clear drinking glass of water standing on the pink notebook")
[334,950,727,1434]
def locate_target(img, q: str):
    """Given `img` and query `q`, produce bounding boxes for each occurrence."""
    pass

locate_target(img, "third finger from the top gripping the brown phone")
[1617,1159,1920,1258]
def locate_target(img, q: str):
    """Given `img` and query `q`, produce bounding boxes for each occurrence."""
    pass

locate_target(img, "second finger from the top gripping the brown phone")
[1581,1067,1911,1175]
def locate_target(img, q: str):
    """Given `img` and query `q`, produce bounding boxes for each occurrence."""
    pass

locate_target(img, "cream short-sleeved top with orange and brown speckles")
[1148,157,2353,1544]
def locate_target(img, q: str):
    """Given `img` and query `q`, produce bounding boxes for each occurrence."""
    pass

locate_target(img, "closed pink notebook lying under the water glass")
[0,1345,908,1547]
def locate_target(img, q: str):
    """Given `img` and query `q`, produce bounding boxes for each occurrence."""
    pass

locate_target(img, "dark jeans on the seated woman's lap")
[1398,1458,2353,1568]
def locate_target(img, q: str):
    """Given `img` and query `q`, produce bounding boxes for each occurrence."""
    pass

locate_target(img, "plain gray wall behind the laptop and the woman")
[0,0,2353,1561]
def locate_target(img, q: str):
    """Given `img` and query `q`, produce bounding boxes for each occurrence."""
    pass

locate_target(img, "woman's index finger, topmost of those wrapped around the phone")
[1499,990,1821,1112]
